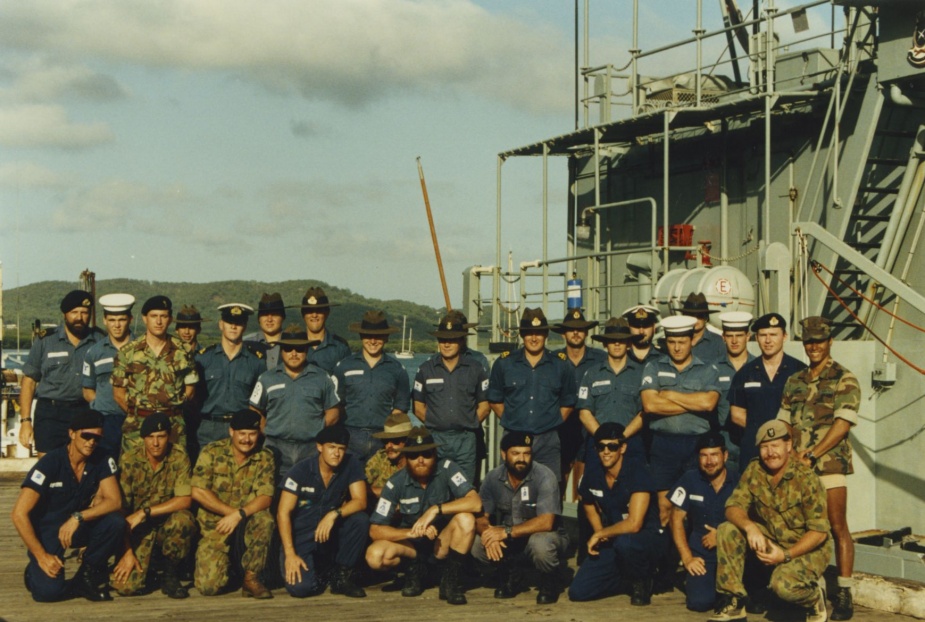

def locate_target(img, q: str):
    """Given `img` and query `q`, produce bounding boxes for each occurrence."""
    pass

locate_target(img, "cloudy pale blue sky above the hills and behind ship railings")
[0,0,824,307]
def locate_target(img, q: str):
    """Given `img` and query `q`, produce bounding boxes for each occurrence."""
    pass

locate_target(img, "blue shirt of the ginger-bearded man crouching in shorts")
[369,459,473,529]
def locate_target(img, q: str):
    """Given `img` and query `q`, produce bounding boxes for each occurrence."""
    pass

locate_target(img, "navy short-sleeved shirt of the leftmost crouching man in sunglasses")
[21,445,119,534]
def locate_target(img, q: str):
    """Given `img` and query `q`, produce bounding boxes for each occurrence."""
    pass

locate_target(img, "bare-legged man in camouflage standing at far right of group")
[777,317,861,620]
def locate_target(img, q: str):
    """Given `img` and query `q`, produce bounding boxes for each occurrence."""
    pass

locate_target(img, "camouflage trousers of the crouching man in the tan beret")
[716,522,832,607]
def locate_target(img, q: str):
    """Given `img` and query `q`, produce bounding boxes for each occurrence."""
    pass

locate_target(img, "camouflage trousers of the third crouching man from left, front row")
[193,510,275,596]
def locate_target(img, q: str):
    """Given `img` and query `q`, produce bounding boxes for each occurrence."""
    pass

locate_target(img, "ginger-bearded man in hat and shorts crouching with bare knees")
[366,428,482,605]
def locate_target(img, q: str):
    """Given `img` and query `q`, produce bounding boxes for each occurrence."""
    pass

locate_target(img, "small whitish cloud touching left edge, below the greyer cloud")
[0,105,113,149]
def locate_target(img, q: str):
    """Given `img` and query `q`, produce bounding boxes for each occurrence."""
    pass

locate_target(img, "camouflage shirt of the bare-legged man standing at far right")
[777,359,861,475]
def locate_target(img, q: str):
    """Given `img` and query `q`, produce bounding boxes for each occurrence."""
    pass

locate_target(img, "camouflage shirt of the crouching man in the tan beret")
[726,454,831,549]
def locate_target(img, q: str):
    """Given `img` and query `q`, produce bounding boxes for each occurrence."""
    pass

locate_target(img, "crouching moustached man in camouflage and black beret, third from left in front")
[191,410,276,599]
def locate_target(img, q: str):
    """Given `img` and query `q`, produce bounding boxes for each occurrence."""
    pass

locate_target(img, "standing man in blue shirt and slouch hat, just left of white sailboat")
[334,311,411,464]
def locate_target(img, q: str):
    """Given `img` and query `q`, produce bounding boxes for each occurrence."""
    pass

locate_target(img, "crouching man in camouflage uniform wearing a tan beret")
[710,419,831,622]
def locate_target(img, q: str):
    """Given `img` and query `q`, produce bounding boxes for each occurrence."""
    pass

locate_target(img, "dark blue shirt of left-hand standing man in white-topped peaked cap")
[196,343,267,416]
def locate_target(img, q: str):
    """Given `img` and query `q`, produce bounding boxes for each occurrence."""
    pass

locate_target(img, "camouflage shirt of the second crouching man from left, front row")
[119,443,192,512]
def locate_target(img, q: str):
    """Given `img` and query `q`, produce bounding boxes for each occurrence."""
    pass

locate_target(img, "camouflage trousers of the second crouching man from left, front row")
[111,510,196,596]
